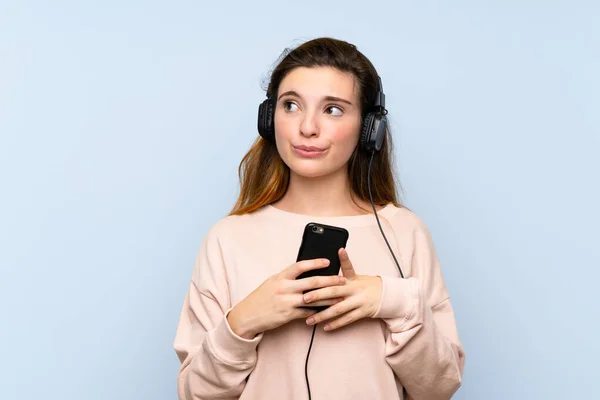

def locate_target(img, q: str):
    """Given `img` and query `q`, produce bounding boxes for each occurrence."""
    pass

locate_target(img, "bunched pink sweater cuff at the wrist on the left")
[206,309,263,364]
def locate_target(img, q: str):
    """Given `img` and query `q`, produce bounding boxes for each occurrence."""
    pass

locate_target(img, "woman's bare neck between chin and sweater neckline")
[274,168,371,217]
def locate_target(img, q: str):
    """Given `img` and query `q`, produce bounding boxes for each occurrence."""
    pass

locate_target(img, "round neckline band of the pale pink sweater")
[264,203,398,226]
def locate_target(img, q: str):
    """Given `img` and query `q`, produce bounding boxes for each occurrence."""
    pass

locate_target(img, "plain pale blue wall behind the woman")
[0,0,600,400]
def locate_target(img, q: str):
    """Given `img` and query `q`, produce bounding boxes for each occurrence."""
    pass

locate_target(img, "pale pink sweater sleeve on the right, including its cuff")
[374,220,465,400]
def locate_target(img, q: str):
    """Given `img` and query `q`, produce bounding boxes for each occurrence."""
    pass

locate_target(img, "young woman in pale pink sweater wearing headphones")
[174,38,464,400]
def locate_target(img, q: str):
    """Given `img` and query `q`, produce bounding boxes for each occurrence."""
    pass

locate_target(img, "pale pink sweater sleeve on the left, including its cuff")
[174,230,262,400]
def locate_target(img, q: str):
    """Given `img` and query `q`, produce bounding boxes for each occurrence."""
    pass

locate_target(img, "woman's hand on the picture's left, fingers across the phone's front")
[227,258,346,339]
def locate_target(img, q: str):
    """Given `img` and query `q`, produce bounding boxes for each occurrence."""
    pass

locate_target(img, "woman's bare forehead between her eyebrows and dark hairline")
[279,67,357,101]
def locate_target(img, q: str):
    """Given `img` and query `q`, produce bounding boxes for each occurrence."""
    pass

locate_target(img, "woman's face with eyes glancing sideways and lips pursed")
[275,67,361,178]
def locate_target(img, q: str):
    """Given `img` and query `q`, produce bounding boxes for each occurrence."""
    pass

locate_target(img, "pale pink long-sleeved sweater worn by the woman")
[174,204,464,400]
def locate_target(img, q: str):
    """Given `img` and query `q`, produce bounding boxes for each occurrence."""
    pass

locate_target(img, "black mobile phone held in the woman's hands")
[296,222,349,311]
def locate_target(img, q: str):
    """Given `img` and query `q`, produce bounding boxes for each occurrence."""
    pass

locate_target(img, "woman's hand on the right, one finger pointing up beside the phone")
[304,248,382,331]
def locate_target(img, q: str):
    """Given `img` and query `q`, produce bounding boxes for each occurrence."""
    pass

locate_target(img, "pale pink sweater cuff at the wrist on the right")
[373,276,419,321]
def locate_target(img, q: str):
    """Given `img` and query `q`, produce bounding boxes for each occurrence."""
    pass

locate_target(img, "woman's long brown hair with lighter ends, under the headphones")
[229,37,402,215]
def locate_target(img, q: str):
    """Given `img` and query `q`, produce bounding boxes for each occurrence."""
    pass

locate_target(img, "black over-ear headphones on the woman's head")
[258,76,388,152]
